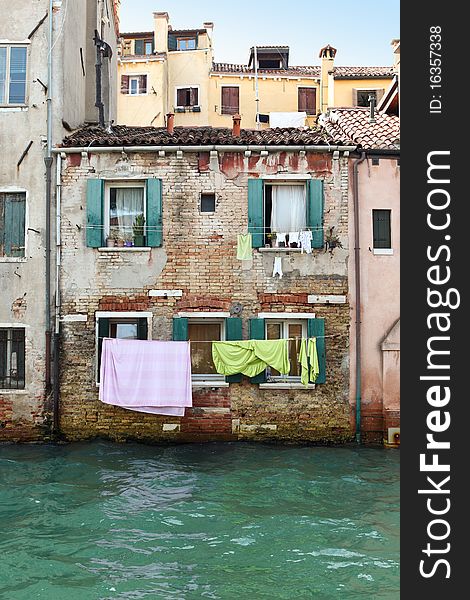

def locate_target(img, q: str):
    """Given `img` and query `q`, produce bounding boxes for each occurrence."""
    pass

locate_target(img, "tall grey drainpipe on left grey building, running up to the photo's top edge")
[44,0,53,418]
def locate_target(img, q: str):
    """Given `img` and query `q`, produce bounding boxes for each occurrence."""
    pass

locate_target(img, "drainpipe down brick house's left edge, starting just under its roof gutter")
[53,154,62,436]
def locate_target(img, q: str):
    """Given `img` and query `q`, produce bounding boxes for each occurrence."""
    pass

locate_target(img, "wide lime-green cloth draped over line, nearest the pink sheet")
[212,340,290,377]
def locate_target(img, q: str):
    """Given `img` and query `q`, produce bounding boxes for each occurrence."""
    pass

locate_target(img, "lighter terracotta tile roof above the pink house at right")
[320,108,400,150]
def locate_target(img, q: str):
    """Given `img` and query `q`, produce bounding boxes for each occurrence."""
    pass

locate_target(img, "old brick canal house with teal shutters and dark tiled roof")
[56,118,355,442]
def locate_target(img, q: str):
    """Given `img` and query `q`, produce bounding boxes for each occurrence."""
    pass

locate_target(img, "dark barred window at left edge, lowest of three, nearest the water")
[0,327,25,390]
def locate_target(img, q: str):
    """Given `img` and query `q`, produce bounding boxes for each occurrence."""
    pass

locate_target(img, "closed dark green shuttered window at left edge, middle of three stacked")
[0,192,26,257]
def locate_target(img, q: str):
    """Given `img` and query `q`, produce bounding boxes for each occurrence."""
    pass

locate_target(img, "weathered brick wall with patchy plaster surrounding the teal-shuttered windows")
[60,148,351,442]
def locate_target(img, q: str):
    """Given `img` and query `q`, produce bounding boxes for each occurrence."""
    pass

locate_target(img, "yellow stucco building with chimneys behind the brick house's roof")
[118,12,395,128]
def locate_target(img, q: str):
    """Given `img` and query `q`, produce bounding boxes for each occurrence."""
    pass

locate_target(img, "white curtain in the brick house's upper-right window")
[271,185,307,233]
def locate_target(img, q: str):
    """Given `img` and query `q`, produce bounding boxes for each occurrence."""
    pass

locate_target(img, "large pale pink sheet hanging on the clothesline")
[99,338,192,416]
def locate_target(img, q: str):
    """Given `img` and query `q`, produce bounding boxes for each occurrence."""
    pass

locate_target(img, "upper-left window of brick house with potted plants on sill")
[105,183,146,246]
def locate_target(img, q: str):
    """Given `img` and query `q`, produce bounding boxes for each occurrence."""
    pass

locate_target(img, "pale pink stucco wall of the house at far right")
[349,157,400,441]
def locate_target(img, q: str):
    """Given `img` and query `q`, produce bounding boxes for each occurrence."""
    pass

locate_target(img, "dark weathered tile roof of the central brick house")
[62,125,351,147]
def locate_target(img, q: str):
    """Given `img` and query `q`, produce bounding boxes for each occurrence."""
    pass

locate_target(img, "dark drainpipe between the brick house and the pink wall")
[353,152,366,444]
